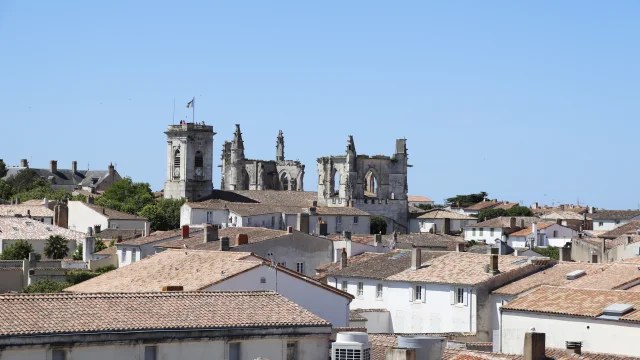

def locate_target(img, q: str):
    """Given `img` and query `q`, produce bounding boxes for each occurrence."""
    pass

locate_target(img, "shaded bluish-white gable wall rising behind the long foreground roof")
[206,265,350,328]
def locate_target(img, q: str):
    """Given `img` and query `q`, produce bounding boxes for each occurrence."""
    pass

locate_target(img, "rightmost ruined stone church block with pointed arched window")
[318,136,409,232]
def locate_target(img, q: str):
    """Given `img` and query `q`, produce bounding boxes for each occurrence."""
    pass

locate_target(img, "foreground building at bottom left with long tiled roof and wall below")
[0,288,331,360]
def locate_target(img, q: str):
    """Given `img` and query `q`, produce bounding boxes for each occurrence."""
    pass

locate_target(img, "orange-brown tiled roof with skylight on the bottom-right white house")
[502,286,640,322]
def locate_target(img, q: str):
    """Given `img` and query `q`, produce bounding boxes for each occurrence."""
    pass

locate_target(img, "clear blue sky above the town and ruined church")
[0,0,640,209]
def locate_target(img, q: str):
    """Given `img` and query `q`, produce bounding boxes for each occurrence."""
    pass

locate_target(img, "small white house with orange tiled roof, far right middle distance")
[507,222,578,248]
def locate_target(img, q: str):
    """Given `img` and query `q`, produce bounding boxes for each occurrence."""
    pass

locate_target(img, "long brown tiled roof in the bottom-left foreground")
[0,291,330,336]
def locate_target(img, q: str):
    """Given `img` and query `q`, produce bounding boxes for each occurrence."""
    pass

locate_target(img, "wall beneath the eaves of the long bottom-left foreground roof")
[2,337,329,360]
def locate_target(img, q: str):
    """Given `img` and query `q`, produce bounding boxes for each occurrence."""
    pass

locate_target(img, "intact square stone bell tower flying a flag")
[164,123,216,201]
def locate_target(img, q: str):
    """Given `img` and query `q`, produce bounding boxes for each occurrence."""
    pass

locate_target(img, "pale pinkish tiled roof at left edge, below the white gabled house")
[0,217,86,241]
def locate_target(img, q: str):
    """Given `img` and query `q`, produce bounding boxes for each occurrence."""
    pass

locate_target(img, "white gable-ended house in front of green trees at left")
[67,201,151,235]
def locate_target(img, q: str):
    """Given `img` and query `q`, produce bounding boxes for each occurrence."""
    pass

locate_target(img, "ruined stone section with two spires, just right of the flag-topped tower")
[220,124,304,191]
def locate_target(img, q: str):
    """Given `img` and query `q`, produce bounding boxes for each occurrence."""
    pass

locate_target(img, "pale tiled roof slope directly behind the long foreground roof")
[65,249,262,293]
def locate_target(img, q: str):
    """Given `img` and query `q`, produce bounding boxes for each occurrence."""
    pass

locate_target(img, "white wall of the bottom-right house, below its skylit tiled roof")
[500,311,640,356]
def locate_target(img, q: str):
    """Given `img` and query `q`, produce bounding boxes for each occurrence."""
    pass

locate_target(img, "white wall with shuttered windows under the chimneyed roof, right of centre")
[327,277,476,333]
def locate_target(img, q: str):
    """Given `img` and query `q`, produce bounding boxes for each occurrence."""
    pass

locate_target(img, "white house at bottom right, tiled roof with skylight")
[500,286,640,356]
